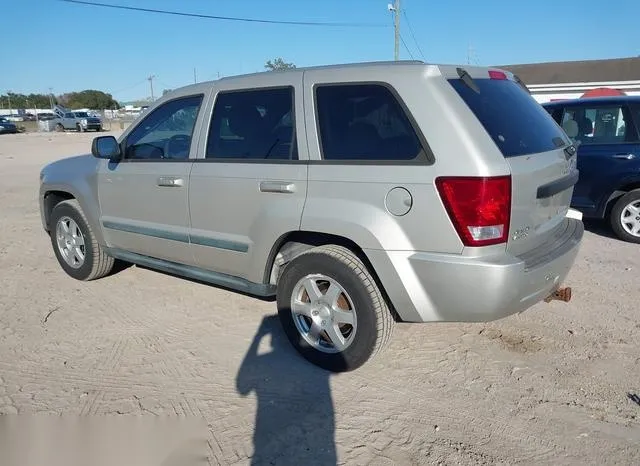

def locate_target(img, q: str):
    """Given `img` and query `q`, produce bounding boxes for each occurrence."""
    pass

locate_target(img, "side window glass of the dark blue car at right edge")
[562,105,638,144]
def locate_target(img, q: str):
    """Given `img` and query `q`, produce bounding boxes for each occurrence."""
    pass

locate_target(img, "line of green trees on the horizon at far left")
[0,89,120,110]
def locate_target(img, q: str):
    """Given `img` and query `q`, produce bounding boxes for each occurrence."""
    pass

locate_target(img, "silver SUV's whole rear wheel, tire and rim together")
[277,246,394,372]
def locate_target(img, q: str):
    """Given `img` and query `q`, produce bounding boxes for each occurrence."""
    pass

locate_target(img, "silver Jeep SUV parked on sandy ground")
[40,62,584,371]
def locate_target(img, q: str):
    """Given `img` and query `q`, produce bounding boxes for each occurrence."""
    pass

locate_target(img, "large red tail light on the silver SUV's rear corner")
[436,176,511,246]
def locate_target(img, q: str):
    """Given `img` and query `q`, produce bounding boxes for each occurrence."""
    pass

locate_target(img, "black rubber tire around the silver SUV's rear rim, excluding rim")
[277,245,395,372]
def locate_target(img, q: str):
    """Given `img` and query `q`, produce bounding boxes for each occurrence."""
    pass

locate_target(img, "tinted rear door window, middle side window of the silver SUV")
[206,87,298,160]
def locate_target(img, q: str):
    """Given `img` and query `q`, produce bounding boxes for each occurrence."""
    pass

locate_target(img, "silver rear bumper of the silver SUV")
[365,218,584,322]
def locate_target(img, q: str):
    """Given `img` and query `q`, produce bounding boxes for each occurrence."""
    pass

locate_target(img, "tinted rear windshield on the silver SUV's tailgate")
[449,79,568,157]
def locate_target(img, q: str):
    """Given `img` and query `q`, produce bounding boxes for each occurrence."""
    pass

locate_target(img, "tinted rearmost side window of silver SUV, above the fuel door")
[316,84,422,160]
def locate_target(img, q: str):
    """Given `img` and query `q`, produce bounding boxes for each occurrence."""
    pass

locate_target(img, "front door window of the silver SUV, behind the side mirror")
[125,95,202,160]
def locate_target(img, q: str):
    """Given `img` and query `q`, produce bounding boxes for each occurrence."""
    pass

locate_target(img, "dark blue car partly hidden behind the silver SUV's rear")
[543,96,640,243]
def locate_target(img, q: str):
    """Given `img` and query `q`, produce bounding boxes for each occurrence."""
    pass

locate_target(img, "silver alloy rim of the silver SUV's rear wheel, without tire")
[291,274,357,353]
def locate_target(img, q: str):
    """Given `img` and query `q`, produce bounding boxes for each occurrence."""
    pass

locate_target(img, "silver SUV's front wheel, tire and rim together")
[50,199,114,281]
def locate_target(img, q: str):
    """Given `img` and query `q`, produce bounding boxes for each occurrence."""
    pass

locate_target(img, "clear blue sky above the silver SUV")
[0,0,640,101]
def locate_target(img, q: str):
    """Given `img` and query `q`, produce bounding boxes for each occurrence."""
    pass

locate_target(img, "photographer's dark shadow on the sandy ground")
[236,315,337,465]
